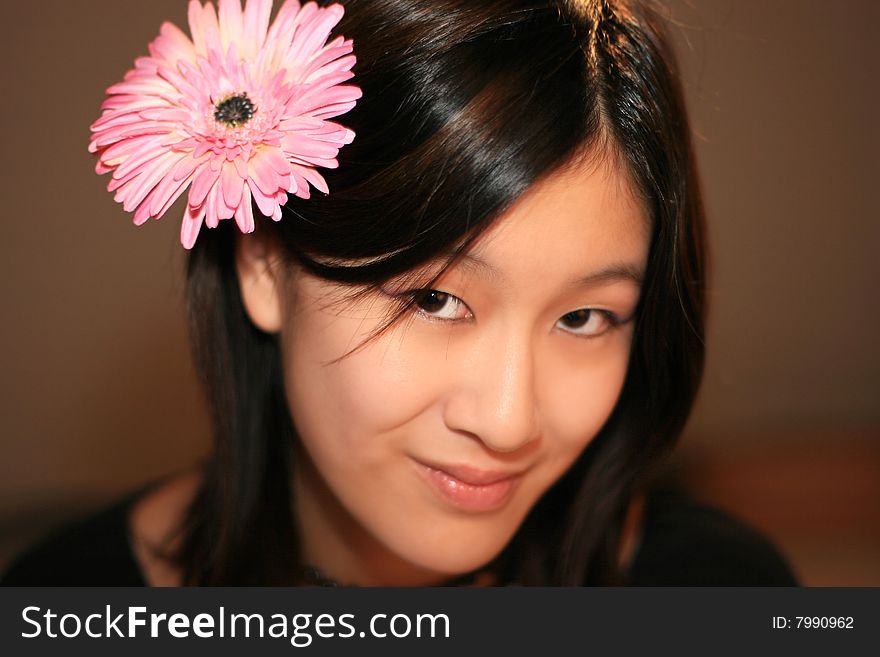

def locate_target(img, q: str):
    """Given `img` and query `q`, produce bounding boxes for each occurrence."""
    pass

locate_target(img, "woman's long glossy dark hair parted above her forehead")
[176,0,705,585]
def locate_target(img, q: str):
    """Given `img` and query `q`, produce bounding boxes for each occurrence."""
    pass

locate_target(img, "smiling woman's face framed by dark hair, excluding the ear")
[268,155,649,585]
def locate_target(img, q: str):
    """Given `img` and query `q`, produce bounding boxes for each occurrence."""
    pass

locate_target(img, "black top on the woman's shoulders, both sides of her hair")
[0,493,797,586]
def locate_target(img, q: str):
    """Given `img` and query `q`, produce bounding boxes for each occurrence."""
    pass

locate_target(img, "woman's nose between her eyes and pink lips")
[444,331,540,452]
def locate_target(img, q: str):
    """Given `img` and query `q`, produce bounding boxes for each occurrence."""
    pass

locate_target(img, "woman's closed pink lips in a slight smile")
[417,461,521,513]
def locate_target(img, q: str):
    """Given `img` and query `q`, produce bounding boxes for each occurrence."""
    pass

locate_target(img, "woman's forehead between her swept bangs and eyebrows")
[455,158,650,284]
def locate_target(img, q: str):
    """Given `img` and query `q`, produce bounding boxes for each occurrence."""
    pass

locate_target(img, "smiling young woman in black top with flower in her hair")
[1,0,792,586]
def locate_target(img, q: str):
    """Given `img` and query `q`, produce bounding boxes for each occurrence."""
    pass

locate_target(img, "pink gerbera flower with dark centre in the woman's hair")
[89,0,361,249]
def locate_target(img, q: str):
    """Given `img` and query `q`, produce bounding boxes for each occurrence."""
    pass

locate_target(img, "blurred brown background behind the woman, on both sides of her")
[0,0,880,586]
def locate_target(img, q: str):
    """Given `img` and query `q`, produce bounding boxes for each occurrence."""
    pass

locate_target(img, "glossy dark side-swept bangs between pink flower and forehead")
[266,3,599,284]
